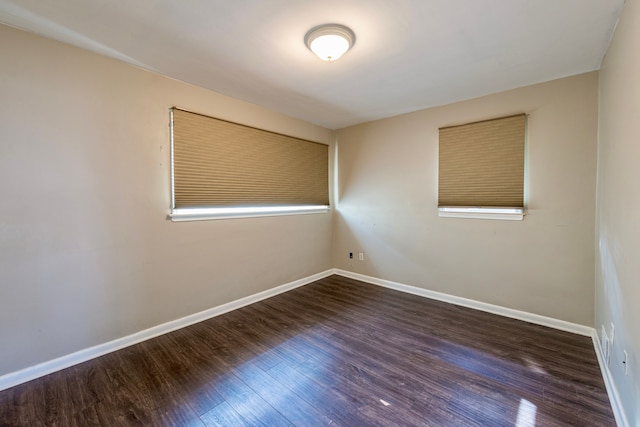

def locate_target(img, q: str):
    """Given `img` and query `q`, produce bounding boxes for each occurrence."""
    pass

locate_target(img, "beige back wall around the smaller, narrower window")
[334,72,598,326]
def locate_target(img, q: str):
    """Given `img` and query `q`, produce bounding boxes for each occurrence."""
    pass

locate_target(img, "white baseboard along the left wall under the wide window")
[0,269,334,391]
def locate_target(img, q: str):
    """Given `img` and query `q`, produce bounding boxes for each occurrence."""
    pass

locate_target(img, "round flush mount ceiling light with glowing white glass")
[304,24,356,61]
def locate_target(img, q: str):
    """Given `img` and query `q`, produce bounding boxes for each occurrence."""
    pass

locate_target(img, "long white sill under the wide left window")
[167,206,330,222]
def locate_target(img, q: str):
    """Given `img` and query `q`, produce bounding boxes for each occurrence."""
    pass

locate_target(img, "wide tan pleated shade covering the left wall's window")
[172,108,329,209]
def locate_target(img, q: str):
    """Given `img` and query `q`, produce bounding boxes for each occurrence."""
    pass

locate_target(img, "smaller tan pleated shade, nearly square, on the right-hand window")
[438,114,526,207]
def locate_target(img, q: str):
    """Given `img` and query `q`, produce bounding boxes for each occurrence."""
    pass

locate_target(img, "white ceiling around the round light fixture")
[0,0,623,129]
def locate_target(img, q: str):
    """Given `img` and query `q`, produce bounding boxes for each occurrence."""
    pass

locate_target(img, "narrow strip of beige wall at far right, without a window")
[596,0,640,426]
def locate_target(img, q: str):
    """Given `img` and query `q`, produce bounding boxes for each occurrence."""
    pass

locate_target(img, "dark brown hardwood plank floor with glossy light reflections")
[0,276,615,427]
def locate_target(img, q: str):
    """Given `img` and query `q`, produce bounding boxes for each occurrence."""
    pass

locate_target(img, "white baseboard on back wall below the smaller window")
[334,269,595,337]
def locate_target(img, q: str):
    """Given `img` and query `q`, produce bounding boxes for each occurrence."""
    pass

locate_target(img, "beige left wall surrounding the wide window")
[0,26,333,375]
